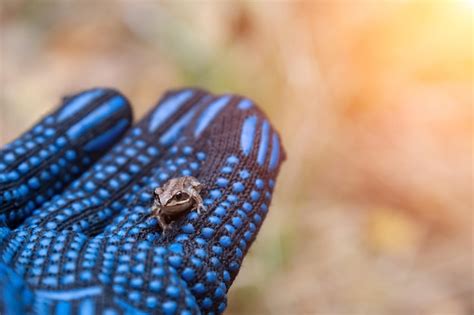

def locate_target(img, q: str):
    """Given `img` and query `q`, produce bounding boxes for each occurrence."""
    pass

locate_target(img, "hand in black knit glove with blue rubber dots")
[0,89,285,314]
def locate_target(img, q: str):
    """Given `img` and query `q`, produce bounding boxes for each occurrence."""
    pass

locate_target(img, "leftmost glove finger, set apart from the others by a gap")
[0,88,132,227]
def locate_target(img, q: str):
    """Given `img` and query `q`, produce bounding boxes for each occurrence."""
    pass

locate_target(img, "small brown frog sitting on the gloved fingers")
[152,176,206,231]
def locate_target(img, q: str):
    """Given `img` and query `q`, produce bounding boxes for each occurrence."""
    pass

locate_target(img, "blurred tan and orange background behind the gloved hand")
[0,0,474,315]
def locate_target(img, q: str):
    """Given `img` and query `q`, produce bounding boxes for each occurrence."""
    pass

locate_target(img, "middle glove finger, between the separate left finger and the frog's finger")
[21,89,210,235]
